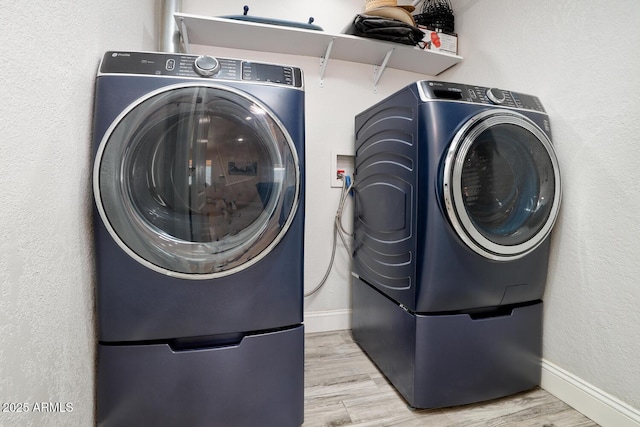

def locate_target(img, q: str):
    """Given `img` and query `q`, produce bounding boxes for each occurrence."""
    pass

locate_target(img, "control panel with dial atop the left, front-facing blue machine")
[99,51,302,87]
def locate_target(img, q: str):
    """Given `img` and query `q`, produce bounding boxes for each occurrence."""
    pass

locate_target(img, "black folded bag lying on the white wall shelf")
[352,15,424,46]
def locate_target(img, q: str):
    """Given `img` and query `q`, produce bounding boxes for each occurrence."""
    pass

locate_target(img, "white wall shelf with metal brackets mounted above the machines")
[174,13,462,85]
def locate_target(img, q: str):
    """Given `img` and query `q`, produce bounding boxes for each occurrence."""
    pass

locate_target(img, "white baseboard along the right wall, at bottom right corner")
[540,359,640,427]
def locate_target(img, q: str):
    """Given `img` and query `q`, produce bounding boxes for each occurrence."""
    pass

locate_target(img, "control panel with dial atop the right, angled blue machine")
[418,80,545,112]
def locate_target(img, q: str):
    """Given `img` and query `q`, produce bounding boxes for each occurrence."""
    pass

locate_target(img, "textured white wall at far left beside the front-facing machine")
[0,0,156,426]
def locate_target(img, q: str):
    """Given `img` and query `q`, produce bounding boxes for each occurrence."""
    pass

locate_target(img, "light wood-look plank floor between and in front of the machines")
[304,331,597,427]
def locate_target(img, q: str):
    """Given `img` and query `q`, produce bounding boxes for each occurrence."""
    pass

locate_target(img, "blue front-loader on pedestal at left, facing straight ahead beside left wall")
[93,52,304,427]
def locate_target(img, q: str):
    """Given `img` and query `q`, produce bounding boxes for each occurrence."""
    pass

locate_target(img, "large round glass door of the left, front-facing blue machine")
[94,85,300,279]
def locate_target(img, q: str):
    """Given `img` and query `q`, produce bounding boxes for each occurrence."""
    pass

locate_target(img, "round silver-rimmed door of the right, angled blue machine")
[443,111,561,260]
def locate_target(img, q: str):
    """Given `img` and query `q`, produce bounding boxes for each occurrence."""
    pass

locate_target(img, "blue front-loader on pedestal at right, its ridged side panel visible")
[352,81,561,408]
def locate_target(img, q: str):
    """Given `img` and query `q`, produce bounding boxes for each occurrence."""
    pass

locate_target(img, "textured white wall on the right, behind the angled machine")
[445,0,640,408]
